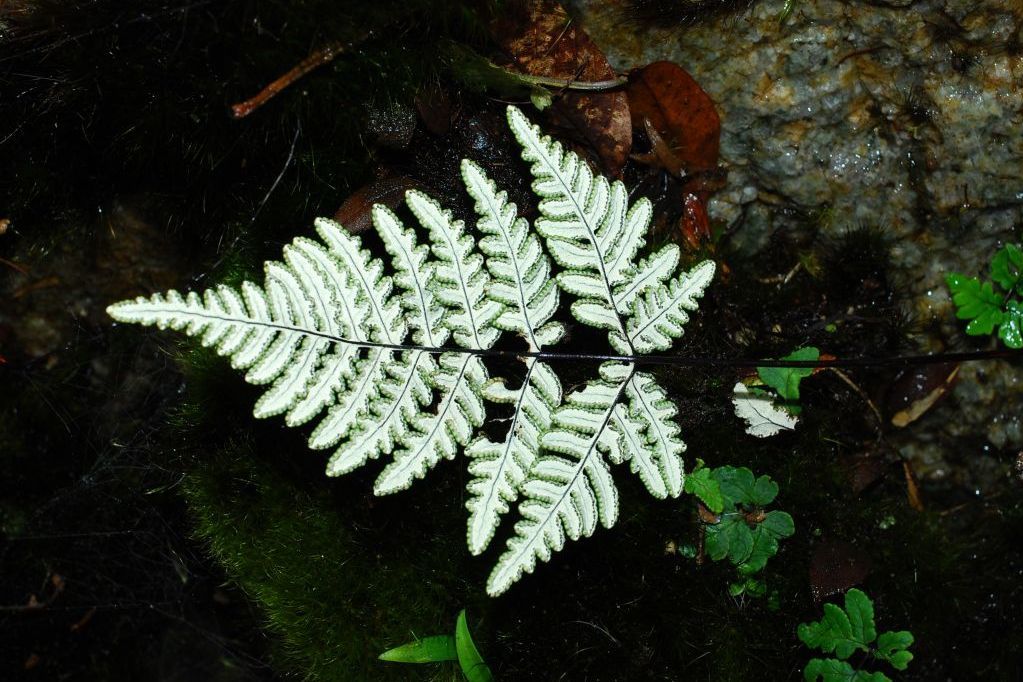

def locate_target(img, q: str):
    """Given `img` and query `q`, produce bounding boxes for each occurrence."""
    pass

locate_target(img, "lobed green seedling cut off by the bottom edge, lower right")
[797,588,913,682]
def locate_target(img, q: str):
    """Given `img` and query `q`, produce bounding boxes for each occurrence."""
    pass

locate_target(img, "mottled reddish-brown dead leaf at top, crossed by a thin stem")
[491,0,632,176]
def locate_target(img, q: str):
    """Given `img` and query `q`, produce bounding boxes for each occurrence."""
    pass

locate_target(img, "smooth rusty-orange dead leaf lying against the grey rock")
[627,61,721,175]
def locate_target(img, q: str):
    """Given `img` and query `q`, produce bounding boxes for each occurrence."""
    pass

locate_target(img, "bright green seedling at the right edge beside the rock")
[945,244,1023,349]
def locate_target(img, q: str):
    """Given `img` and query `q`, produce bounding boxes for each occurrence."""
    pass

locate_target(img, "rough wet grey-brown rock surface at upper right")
[573,0,1023,476]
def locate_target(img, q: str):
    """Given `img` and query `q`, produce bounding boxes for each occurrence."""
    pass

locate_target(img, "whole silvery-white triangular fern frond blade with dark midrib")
[107,107,714,595]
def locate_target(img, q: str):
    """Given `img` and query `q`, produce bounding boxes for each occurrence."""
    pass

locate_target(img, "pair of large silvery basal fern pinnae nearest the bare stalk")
[487,108,714,594]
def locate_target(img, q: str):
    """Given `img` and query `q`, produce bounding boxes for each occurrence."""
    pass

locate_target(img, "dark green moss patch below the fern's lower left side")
[184,439,491,680]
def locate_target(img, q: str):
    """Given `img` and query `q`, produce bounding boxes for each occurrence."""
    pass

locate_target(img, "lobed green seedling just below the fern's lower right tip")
[685,462,796,596]
